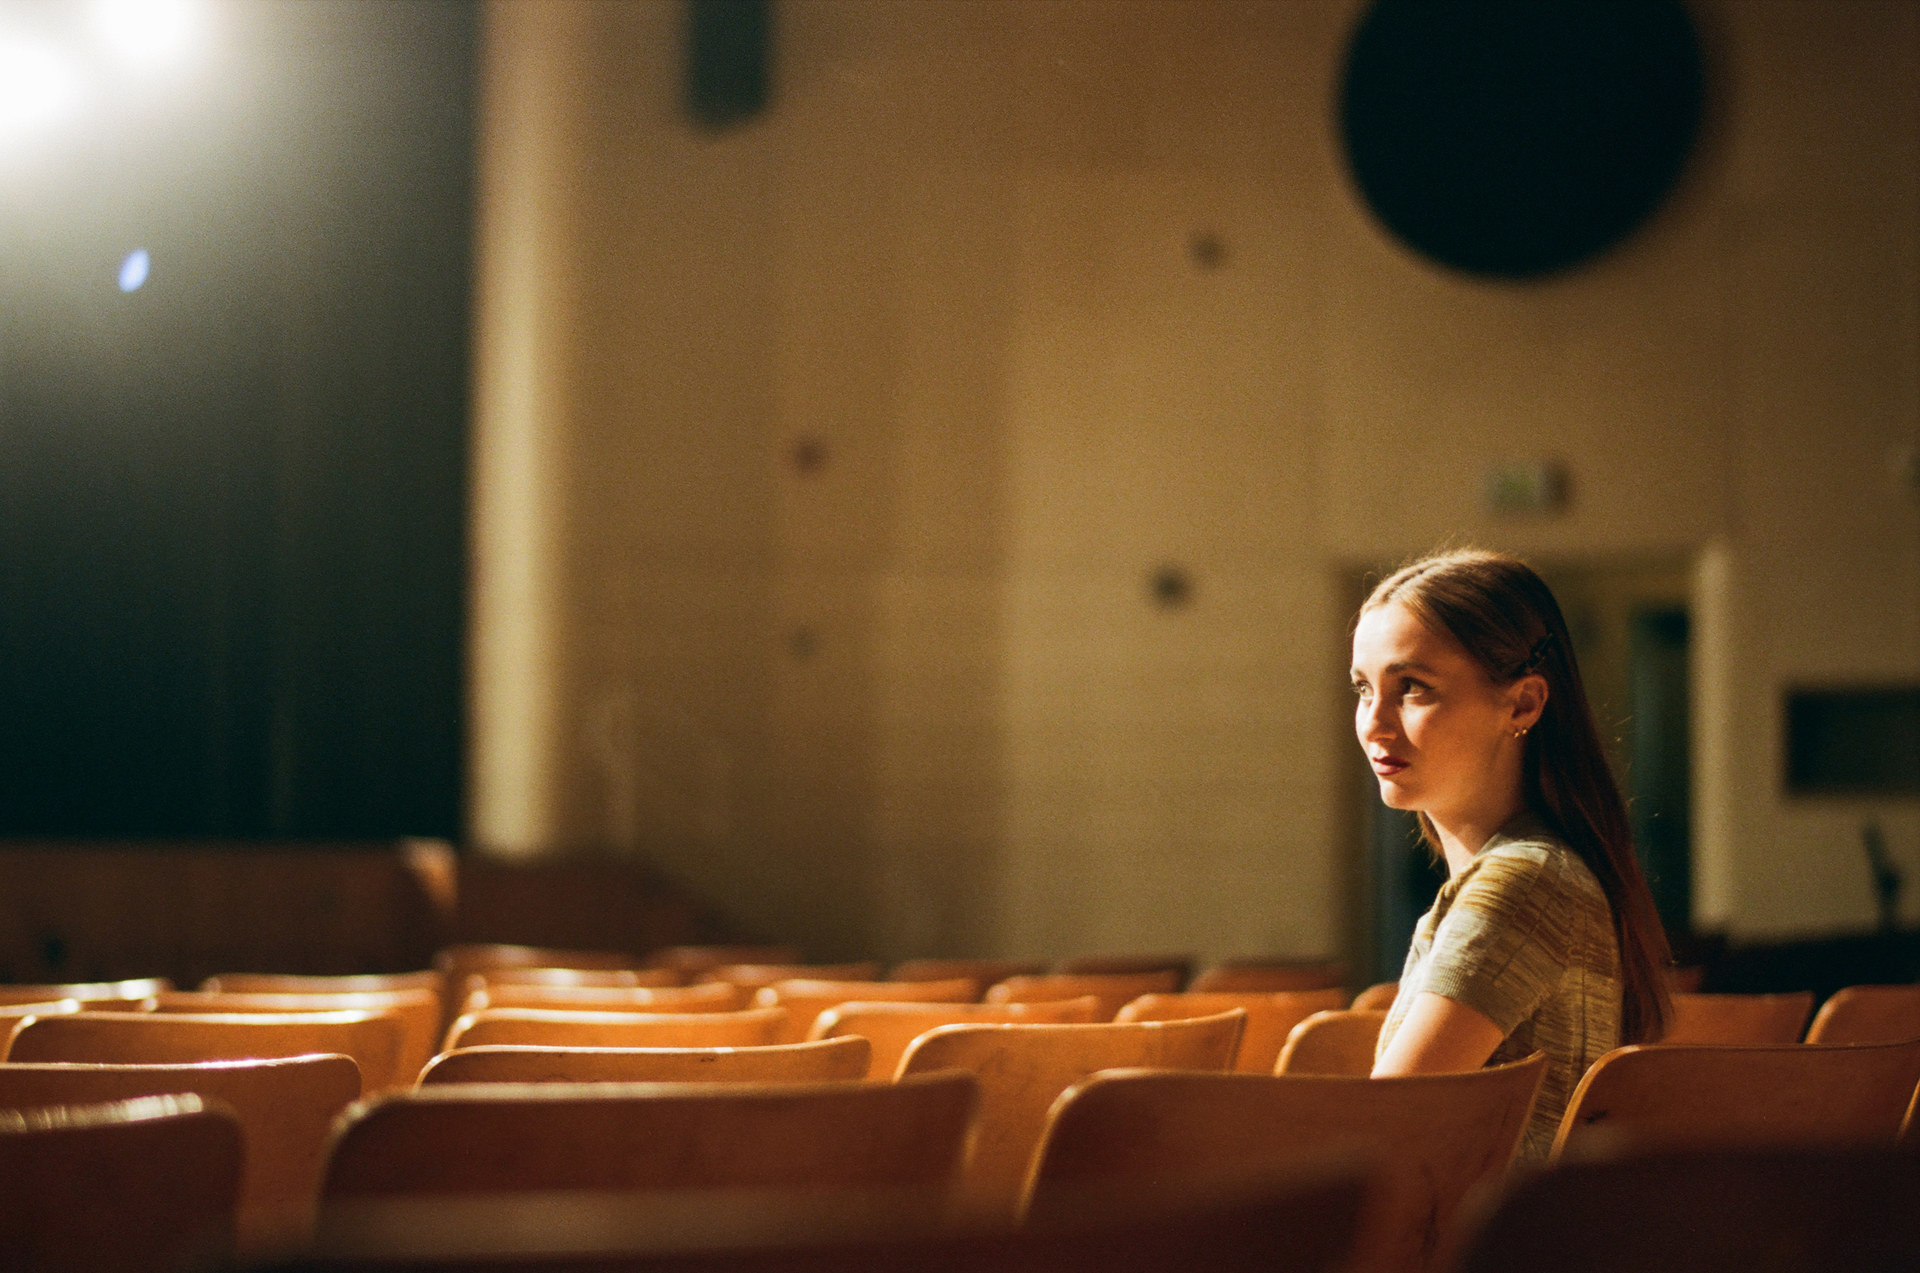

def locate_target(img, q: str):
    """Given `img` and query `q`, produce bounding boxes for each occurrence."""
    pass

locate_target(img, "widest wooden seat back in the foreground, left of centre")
[323,1073,979,1215]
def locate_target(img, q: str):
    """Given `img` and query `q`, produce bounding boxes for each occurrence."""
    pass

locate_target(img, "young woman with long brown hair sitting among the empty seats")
[1354,551,1670,1162]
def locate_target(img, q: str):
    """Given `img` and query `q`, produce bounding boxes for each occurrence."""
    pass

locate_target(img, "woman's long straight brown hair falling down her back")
[1359,549,1672,1043]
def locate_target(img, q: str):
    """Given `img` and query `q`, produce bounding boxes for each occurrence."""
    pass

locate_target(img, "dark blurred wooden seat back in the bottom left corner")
[0,1094,242,1273]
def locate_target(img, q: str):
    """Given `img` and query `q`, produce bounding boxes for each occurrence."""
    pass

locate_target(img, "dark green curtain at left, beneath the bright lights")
[0,0,476,839]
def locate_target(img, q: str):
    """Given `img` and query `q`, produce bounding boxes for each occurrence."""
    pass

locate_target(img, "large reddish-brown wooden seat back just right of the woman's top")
[1553,1041,1920,1160]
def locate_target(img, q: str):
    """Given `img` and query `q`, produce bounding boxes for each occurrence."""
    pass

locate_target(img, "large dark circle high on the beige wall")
[1340,0,1703,278]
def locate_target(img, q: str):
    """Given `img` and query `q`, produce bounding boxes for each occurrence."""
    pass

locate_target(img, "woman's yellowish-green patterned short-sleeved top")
[1375,818,1620,1162]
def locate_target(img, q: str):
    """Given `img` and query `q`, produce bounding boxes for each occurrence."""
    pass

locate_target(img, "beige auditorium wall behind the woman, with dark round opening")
[470,0,1920,956]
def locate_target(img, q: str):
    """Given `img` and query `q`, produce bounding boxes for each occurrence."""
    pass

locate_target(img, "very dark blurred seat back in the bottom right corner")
[1453,1146,1920,1273]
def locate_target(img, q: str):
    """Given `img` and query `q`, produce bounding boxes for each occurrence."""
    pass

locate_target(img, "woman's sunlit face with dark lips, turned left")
[1354,601,1544,820]
